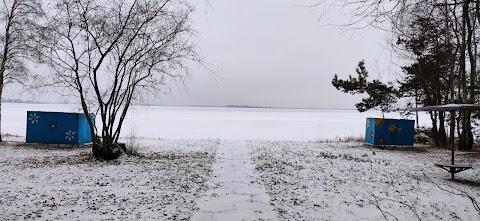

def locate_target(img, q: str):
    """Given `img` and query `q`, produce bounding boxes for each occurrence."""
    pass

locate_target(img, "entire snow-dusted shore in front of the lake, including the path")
[0,138,480,220]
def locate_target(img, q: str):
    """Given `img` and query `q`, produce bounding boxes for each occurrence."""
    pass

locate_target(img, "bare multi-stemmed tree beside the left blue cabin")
[43,0,200,160]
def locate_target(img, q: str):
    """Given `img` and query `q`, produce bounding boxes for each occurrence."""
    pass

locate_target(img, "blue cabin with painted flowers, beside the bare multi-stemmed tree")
[26,111,95,145]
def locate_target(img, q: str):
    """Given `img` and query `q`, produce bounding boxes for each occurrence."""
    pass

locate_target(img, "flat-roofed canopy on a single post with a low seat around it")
[409,104,480,179]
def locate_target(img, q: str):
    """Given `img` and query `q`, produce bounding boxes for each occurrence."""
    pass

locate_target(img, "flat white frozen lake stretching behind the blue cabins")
[2,103,431,141]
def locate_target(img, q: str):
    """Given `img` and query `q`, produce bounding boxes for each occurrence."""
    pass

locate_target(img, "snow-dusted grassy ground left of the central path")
[0,140,219,220]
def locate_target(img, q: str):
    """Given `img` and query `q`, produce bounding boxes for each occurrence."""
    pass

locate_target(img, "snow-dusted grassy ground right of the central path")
[248,141,480,220]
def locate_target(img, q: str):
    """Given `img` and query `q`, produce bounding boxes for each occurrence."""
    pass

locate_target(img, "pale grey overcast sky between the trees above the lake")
[5,0,398,108]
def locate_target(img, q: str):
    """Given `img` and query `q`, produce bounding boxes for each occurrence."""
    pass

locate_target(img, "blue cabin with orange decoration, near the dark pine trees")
[365,118,415,146]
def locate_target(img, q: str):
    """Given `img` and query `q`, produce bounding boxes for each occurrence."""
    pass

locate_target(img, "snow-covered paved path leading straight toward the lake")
[191,141,277,221]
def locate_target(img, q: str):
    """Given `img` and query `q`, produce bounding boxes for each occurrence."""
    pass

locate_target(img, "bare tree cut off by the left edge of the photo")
[0,0,43,142]
